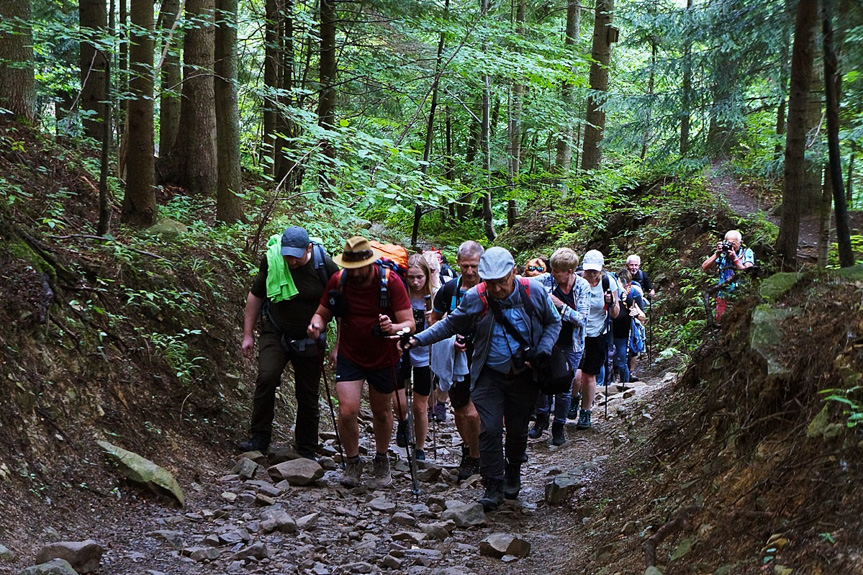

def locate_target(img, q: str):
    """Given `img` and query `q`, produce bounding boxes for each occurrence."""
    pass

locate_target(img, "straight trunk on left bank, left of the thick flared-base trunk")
[122,0,156,227]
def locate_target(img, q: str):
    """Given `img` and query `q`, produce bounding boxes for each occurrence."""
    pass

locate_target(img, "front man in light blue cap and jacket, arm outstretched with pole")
[405,247,560,511]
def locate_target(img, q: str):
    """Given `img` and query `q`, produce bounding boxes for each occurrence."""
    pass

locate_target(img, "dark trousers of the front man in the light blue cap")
[471,367,539,481]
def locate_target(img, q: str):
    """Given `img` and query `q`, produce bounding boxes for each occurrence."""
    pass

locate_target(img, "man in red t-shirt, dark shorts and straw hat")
[307,236,414,487]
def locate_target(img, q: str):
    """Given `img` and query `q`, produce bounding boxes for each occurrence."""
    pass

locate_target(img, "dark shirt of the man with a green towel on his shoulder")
[251,248,339,339]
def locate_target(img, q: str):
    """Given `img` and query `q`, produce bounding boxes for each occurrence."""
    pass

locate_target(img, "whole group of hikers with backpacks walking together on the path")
[240,226,752,511]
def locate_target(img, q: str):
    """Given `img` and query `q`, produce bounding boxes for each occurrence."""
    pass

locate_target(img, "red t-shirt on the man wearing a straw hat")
[321,266,411,369]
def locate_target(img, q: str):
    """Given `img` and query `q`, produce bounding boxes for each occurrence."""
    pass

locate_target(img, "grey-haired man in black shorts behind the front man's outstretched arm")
[431,240,485,481]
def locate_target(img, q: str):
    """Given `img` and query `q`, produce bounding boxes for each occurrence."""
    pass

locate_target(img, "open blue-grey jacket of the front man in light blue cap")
[414,279,560,387]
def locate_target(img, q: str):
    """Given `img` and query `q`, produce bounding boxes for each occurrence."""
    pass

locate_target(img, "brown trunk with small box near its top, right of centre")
[581,0,614,170]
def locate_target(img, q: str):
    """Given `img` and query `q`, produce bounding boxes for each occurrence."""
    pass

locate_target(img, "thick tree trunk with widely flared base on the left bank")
[159,0,218,196]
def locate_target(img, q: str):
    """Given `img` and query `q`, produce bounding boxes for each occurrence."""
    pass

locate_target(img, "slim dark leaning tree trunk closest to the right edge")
[822,0,854,268]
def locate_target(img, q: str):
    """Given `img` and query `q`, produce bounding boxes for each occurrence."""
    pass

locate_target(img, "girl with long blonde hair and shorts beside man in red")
[396,254,432,461]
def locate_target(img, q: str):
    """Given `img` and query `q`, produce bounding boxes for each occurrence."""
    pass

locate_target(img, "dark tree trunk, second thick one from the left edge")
[78,0,108,140]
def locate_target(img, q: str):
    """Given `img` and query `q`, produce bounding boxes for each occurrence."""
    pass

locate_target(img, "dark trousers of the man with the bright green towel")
[251,330,321,454]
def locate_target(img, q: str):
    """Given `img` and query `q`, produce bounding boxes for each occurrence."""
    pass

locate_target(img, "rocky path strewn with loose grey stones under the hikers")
[16,375,672,575]
